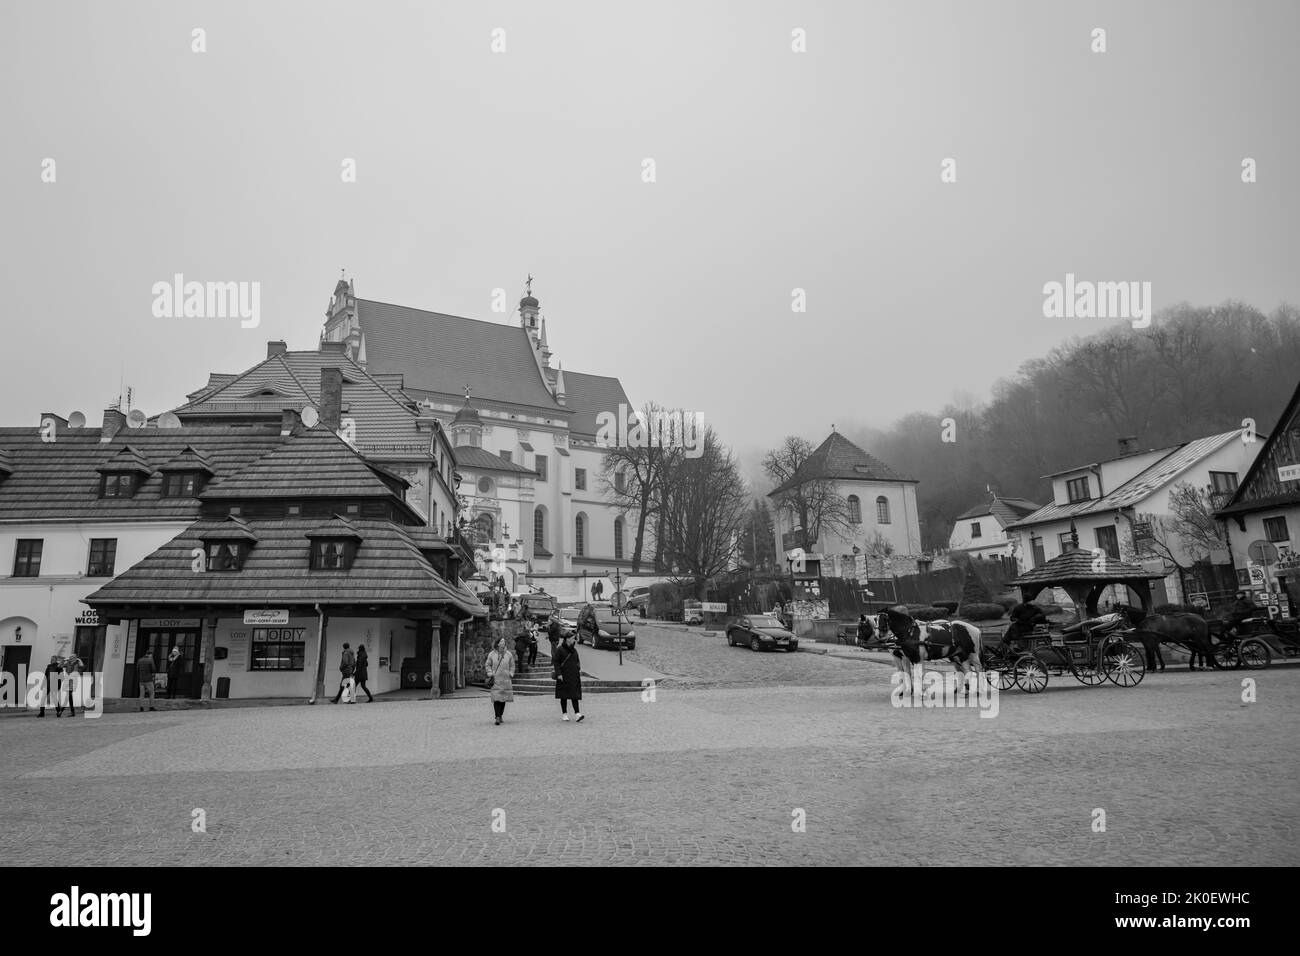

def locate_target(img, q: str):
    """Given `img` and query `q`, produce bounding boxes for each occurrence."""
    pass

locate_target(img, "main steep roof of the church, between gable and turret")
[356,299,568,418]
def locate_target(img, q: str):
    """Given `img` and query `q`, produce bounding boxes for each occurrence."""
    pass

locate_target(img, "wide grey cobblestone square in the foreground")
[0,650,1300,865]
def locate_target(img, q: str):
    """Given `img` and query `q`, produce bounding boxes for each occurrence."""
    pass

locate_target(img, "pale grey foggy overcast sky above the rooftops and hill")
[0,0,1300,476]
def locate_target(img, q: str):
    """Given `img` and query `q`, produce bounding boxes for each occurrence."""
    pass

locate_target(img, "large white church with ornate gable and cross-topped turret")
[321,280,636,593]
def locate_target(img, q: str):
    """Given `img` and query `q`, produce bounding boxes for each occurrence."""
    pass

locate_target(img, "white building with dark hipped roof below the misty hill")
[767,432,927,578]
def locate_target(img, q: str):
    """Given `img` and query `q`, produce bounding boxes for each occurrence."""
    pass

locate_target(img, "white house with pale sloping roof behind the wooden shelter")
[1006,431,1261,605]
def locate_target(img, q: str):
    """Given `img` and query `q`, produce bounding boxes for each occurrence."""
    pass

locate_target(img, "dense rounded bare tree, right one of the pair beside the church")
[657,428,749,597]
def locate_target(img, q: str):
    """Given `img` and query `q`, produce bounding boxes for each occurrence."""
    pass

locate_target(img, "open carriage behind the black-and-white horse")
[980,614,1147,693]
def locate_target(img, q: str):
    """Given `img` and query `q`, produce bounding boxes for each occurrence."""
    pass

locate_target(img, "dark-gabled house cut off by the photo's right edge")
[1218,385,1300,615]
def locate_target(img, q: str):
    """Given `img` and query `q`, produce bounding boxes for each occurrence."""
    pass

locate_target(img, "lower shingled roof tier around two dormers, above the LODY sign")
[85,518,484,615]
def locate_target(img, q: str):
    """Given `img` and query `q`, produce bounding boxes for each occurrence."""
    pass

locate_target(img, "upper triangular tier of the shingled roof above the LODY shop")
[199,424,404,501]
